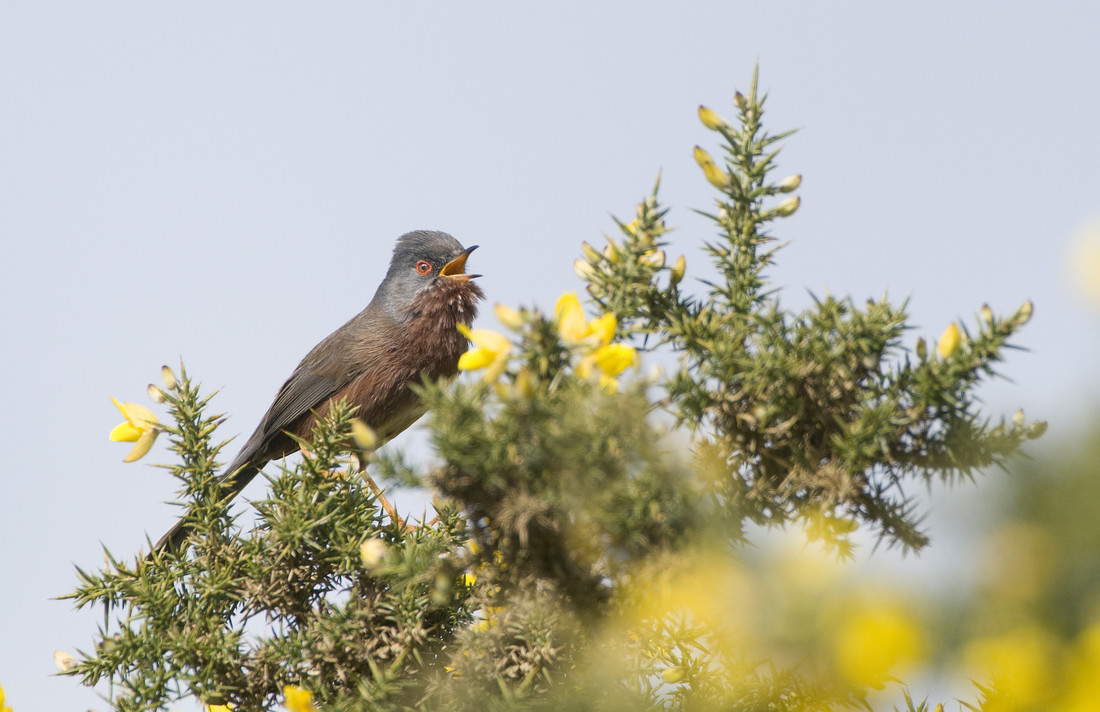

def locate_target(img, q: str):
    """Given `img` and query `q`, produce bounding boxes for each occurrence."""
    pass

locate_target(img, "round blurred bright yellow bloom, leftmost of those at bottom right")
[833,601,924,687]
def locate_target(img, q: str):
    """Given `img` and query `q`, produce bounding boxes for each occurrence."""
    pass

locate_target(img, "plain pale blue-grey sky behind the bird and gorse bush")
[0,0,1100,712]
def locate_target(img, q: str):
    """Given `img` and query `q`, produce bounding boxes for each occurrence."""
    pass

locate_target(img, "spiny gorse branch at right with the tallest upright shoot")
[578,66,1043,549]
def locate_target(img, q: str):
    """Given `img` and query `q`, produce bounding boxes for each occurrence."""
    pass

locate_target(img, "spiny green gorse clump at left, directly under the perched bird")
[68,371,470,710]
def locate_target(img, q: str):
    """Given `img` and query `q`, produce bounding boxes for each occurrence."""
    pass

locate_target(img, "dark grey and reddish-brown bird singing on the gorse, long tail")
[156,230,485,550]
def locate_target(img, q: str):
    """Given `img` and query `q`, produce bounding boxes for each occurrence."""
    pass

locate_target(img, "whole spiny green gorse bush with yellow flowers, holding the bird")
[67,68,1056,712]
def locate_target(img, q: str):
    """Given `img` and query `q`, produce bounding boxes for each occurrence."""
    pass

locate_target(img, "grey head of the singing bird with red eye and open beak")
[374,230,484,324]
